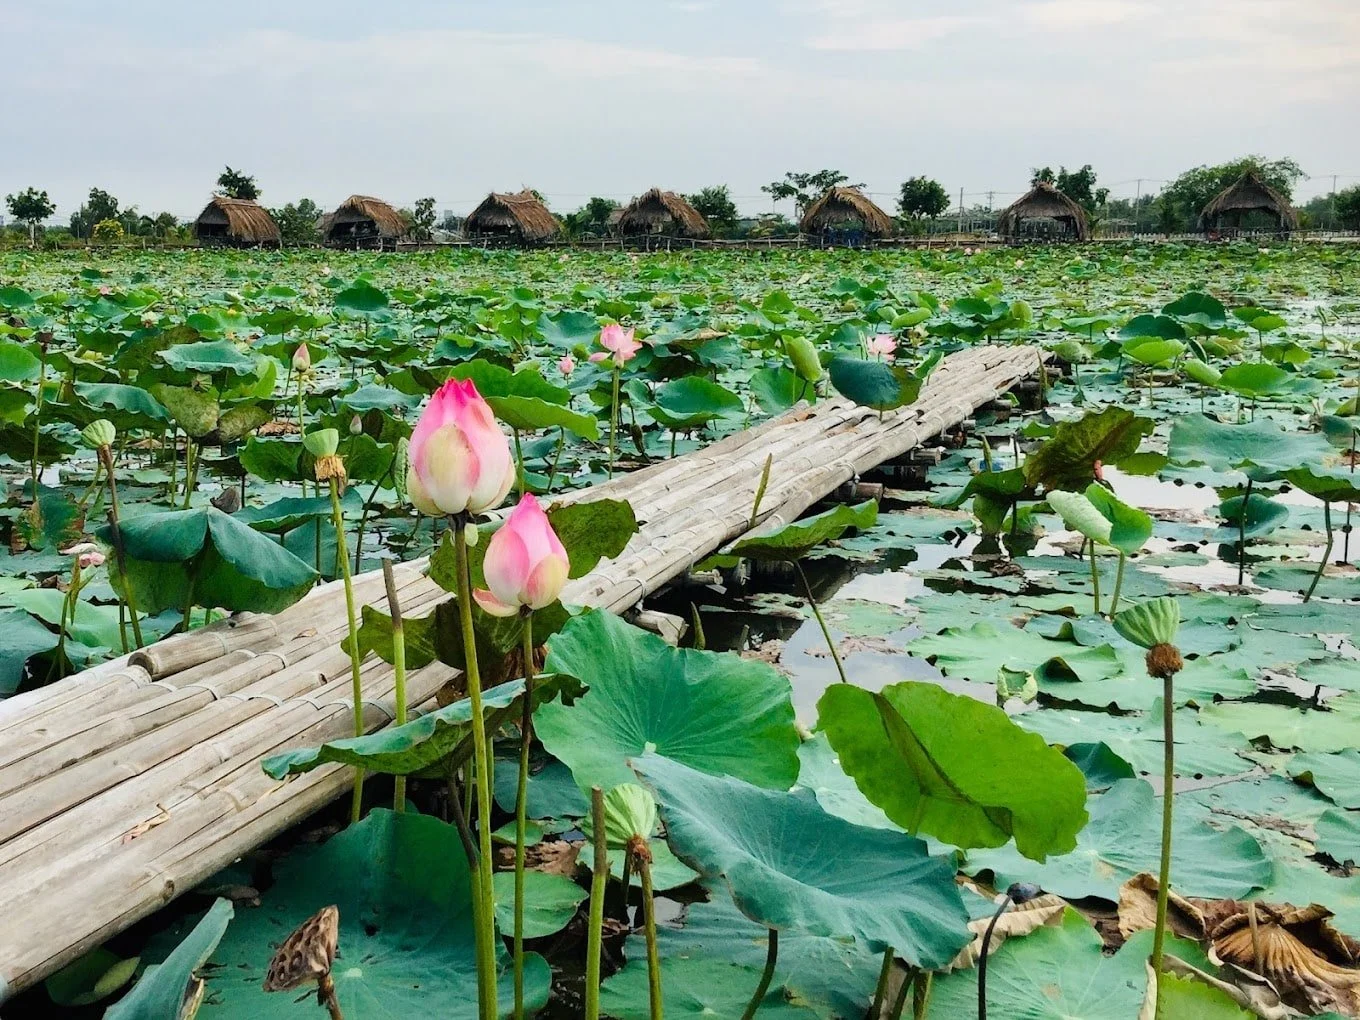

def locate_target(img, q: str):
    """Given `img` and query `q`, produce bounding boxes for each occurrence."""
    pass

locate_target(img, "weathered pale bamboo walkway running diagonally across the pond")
[0,347,1040,1002]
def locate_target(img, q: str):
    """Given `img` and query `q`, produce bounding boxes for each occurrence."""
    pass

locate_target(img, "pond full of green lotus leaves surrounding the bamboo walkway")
[0,245,1360,1020]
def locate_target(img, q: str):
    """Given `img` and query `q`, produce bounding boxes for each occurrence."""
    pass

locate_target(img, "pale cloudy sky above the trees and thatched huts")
[0,0,1360,220]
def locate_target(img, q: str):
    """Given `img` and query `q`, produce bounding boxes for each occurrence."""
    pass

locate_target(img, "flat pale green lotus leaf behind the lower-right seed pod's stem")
[966,779,1272,902]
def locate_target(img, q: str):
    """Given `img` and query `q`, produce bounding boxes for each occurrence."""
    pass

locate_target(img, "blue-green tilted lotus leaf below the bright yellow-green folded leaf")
[634,755,970,970]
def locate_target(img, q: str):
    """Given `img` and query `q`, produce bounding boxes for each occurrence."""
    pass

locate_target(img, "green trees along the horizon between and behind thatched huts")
[5,155,1360,245]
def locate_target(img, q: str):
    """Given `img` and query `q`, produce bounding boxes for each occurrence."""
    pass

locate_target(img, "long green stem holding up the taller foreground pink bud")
[453,514,499,1020]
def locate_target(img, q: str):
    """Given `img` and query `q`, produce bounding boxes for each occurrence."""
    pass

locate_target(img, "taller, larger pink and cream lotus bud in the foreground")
[407,379,515,517]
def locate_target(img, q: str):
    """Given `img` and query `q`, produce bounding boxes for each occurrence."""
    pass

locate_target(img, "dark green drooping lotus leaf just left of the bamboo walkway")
[97,507,317,613]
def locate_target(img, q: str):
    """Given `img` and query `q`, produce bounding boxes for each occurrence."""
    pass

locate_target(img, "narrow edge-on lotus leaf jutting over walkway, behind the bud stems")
[262,675,579,779]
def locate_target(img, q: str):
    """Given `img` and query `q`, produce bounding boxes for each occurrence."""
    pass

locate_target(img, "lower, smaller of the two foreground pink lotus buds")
[472,492,571,616]
